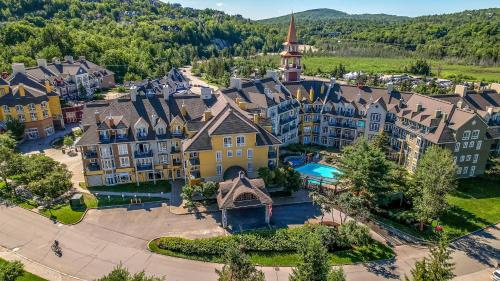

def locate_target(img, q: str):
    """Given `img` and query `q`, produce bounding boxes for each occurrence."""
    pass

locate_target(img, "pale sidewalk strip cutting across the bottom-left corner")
[0,246,83,281]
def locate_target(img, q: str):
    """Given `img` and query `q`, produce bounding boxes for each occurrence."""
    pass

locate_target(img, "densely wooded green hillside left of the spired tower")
[0,0,284,80]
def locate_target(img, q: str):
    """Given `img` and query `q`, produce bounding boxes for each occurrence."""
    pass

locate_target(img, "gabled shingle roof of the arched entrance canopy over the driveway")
[217,172,273,209]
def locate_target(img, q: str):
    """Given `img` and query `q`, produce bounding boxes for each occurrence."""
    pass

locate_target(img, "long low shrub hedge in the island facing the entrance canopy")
[155,223,371,256]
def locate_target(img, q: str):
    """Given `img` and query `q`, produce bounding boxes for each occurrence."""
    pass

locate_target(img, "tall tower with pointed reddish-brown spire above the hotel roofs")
[280,14,302,82]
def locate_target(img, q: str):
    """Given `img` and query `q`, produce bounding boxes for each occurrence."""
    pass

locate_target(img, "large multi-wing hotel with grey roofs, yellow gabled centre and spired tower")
[77,17,500,186]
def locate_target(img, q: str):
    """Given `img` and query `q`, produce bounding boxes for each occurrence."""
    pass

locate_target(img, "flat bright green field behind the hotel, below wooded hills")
[294,56,500,82]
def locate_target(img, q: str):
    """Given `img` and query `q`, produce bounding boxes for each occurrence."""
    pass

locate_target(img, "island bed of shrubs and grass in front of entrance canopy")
[149,223,394,266]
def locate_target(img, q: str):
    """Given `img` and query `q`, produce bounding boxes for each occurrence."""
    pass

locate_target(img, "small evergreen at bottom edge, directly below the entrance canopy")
[215,243,265,281]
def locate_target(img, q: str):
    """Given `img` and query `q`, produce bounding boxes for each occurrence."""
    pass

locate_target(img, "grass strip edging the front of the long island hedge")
[149,240,394,266]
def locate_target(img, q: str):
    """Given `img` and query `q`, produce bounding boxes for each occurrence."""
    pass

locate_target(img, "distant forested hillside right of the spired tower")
[264,8,500,65]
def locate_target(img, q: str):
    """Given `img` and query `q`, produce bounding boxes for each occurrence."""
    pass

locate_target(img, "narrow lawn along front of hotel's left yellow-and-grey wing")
[41,194,165,224]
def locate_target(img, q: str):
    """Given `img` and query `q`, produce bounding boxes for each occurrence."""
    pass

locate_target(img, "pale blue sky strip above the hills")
[162,0,500,19]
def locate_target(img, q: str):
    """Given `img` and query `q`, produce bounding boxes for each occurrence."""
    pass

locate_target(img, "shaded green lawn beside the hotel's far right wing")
[378,178,500,239]
